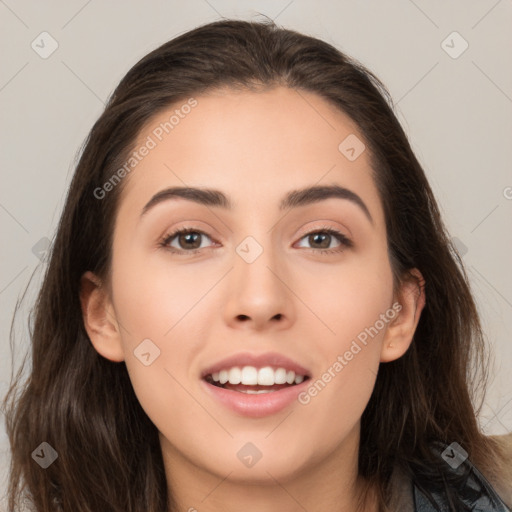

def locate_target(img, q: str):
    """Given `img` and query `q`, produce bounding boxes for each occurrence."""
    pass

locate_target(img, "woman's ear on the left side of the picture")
[80,271,124,362]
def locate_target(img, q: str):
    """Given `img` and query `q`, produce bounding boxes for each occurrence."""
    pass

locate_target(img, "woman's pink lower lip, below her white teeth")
[201,379,309,418]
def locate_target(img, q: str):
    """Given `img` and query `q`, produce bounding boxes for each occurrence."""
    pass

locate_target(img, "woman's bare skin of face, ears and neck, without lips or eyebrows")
[81,87,425,512]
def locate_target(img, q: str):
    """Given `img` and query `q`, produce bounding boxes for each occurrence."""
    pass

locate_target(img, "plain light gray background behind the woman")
[0,0,512,504]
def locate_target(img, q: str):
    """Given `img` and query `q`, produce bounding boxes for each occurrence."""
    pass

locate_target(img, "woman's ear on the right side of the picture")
[380,268,425,363]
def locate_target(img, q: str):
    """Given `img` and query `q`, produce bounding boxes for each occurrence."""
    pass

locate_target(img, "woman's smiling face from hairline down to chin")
[83,88,420,488]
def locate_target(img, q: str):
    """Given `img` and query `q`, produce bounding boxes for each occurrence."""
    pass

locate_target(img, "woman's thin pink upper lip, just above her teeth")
[201,352,310,378]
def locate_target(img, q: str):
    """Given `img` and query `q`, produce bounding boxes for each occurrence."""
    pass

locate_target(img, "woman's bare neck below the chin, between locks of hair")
[161,428,377,512]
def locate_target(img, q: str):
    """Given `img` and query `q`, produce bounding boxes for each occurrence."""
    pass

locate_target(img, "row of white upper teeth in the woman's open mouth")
[212,366,305,386]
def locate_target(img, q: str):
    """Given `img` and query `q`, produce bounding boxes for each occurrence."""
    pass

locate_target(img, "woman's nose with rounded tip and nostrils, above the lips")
[224,240,295,331]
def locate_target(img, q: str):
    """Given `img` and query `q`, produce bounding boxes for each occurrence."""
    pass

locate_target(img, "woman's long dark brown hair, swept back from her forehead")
[4,20,508,512]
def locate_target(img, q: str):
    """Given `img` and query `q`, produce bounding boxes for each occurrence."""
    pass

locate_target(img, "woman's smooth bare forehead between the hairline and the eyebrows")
[115,87,378,222]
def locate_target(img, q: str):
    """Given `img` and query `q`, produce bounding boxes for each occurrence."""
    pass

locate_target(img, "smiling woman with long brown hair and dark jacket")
[6,20,512,512]
